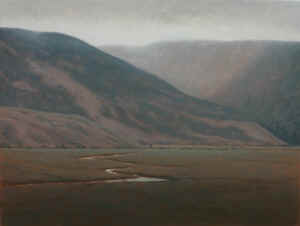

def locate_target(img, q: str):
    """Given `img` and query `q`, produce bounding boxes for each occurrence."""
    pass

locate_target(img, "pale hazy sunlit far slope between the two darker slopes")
[100,41,266,99]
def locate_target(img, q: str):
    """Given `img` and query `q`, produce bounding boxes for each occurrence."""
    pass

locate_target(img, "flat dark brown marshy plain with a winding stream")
[0,148,300,226]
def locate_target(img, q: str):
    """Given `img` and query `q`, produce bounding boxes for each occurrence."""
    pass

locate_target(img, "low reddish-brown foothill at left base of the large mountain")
[0,107,122,148]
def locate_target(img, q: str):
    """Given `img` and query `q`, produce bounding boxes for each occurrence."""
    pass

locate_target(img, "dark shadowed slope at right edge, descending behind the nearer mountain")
[213,42,300,145]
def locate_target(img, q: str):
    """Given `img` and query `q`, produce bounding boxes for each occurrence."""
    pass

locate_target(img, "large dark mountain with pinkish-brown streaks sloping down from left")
[0,28,284,147]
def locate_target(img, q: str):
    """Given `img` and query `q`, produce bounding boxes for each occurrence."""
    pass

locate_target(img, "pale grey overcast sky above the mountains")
[0,0,300,46]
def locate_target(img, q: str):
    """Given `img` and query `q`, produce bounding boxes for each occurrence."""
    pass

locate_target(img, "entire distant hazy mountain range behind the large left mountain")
[103,41,300,145]
